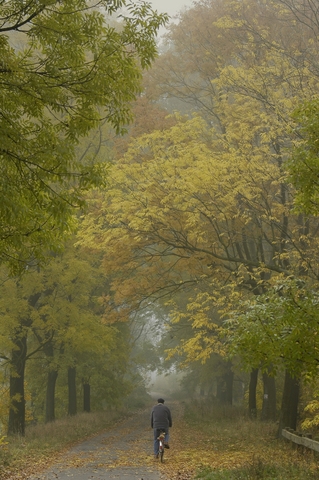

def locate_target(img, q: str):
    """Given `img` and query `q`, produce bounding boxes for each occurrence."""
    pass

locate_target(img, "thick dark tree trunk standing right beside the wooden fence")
[278,370,300,437]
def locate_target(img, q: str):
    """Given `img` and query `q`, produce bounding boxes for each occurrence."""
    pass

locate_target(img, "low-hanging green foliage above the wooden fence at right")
[225,278,319,379]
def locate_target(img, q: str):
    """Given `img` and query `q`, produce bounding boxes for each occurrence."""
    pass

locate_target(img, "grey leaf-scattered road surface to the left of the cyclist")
[28,410,169,480]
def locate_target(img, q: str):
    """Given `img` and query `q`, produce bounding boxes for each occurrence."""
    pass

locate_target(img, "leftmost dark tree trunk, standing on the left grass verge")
[8,335,27,435]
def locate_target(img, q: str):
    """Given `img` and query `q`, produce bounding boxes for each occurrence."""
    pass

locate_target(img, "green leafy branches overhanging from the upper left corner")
[0,0,167,272]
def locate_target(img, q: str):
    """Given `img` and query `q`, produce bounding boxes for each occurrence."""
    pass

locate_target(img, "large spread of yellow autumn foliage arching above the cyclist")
[81,104,318,361]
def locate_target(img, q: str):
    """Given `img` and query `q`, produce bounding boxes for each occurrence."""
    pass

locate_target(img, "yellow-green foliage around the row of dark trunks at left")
[0,244,136,424]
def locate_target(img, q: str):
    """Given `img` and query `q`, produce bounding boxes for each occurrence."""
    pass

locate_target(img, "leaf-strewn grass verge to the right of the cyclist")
[162,402,319,480]
